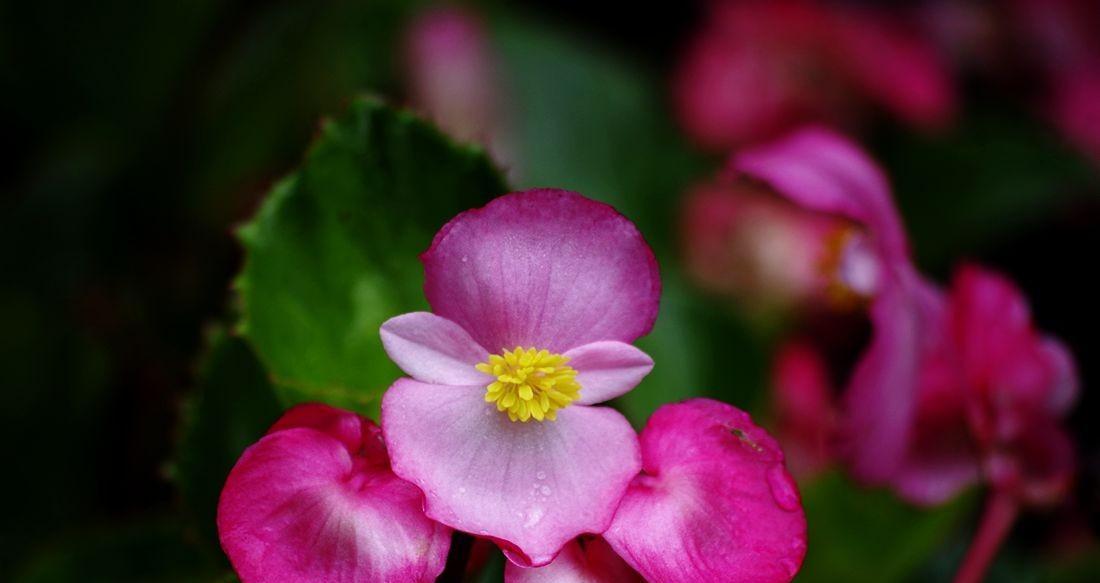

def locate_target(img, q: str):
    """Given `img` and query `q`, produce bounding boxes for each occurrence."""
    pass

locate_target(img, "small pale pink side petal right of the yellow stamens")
[565,341,653,405]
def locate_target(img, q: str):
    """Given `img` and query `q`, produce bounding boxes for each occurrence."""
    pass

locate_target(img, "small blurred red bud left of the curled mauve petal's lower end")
[771,341,837,479]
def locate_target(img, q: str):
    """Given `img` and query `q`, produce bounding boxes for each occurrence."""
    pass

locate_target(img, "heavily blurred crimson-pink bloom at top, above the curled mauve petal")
[673,0,955,150]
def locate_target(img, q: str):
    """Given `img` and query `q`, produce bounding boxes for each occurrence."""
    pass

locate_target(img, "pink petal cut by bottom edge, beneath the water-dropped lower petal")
[504,537,644,583]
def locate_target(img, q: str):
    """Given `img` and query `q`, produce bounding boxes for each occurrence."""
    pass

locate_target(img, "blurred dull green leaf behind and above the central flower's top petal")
[494,14,711,251]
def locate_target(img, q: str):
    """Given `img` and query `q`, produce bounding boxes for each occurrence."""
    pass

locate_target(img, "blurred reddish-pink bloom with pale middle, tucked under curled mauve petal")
[680,176,850,311]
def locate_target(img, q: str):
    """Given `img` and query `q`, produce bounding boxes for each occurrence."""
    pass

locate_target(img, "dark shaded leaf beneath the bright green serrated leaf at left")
[174,327,282,556]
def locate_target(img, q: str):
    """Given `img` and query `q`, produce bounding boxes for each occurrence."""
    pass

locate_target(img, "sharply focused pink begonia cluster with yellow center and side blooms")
[218,189,806,583]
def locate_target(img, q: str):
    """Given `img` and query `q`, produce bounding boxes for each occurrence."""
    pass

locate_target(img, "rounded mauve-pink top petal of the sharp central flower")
[420,189,661,353]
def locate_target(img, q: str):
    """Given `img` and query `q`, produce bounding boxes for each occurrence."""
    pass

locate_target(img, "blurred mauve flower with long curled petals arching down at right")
[733,128,936,490]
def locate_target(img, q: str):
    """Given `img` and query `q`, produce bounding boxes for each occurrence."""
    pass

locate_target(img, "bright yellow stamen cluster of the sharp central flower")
[476,347,581,422]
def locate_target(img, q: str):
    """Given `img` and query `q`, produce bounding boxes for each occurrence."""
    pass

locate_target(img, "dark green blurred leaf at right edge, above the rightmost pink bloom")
[878,103,1100,272]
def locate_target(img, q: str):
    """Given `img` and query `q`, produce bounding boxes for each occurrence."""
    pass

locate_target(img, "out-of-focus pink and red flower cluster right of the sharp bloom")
[684,128,1077,574]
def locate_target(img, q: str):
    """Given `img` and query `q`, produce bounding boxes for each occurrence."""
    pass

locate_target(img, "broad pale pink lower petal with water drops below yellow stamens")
[382,378,641,565]
